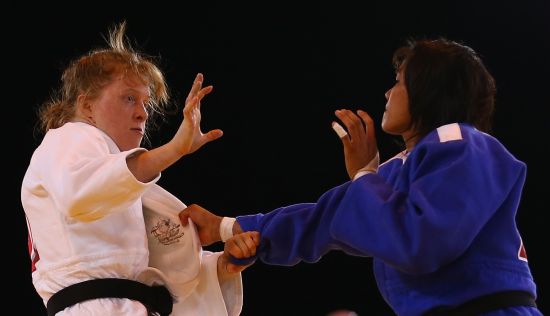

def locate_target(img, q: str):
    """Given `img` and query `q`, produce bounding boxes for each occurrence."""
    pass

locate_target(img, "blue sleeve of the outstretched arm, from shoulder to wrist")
[237,140,525,274]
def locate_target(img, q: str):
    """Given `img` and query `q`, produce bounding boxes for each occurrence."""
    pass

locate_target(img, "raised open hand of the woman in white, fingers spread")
[171,73,223,155]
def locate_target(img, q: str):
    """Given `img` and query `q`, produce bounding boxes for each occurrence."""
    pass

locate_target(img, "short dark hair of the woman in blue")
[393,38,496,137]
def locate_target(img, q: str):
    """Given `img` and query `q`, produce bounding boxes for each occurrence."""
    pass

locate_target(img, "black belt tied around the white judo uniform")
[47,279,173,316]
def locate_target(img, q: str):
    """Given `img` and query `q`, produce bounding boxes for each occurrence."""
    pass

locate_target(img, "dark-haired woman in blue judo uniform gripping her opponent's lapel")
[180,39,541,315]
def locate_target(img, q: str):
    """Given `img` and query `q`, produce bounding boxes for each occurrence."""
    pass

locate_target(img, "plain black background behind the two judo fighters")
[10,0,550,315]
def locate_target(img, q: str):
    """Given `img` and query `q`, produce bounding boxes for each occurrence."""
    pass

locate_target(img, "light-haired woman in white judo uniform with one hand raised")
[21,24,259,316]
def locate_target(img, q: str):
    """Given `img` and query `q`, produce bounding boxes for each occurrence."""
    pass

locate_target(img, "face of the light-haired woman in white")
[91,77,150,151]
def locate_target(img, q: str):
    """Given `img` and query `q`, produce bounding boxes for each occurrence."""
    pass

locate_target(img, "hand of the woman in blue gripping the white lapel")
[179,204,222,246]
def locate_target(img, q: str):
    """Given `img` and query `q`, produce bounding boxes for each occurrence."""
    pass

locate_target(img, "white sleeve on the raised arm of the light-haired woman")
[36,123,160,222]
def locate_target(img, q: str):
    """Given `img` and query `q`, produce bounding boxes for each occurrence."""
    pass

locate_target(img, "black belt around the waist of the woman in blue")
[424,291,537,316]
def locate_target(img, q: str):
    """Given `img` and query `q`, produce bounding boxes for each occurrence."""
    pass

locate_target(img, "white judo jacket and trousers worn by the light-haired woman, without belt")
[21,123,242,316]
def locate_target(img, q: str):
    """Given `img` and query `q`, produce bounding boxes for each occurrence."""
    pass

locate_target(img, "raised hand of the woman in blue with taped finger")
[333,109,378,179]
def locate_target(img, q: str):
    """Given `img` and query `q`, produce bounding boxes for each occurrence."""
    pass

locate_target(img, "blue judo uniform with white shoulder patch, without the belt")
[237,123,541,315]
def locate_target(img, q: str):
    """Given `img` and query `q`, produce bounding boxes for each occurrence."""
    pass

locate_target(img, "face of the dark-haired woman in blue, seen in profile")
[382,70,412,139]
